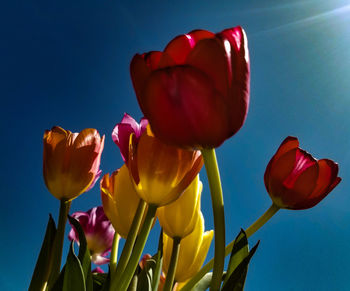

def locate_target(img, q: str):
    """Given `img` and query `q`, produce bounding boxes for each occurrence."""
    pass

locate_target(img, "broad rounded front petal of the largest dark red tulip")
[142,66,230,148]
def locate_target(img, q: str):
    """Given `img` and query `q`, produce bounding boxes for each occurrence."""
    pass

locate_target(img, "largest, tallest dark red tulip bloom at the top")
[130,26,250,148]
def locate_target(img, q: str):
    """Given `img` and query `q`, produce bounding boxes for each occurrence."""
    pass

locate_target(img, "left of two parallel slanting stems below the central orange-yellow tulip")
[112,199,146,281]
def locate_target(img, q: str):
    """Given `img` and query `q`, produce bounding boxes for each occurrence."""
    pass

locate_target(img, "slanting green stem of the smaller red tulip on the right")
[181,203,280,291]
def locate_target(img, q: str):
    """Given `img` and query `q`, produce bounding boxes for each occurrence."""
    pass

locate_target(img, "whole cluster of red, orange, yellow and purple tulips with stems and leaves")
[29,27,341,291]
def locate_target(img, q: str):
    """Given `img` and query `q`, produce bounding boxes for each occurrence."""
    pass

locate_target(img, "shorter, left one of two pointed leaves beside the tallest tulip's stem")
[224,229,249,285]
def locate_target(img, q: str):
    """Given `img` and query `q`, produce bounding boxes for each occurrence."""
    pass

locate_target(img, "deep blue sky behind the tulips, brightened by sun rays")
[0,0,350,291]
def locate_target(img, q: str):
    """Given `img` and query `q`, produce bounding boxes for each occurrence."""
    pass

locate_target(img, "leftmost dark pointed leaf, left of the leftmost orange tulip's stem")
[28,214,57,291]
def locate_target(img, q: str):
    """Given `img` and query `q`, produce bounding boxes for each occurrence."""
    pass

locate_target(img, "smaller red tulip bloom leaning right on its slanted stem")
[264,136,341,209]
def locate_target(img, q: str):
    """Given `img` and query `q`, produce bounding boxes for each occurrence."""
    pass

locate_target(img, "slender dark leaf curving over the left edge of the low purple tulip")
[68,215,93,291]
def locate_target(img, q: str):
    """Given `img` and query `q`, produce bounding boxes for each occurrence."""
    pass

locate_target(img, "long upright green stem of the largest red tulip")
[202,149,225,291]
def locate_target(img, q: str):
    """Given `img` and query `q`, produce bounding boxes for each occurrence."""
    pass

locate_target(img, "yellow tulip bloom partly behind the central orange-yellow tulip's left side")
[101,165,140,238]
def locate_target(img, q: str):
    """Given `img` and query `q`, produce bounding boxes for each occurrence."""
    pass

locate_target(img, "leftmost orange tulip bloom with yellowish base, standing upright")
[43,126,104,200]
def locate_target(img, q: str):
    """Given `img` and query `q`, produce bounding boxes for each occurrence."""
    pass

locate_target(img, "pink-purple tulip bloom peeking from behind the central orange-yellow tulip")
[112,113,148,163]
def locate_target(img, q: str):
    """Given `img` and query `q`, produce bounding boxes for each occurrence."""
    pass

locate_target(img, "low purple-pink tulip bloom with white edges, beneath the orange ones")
[68,206,114,265]
